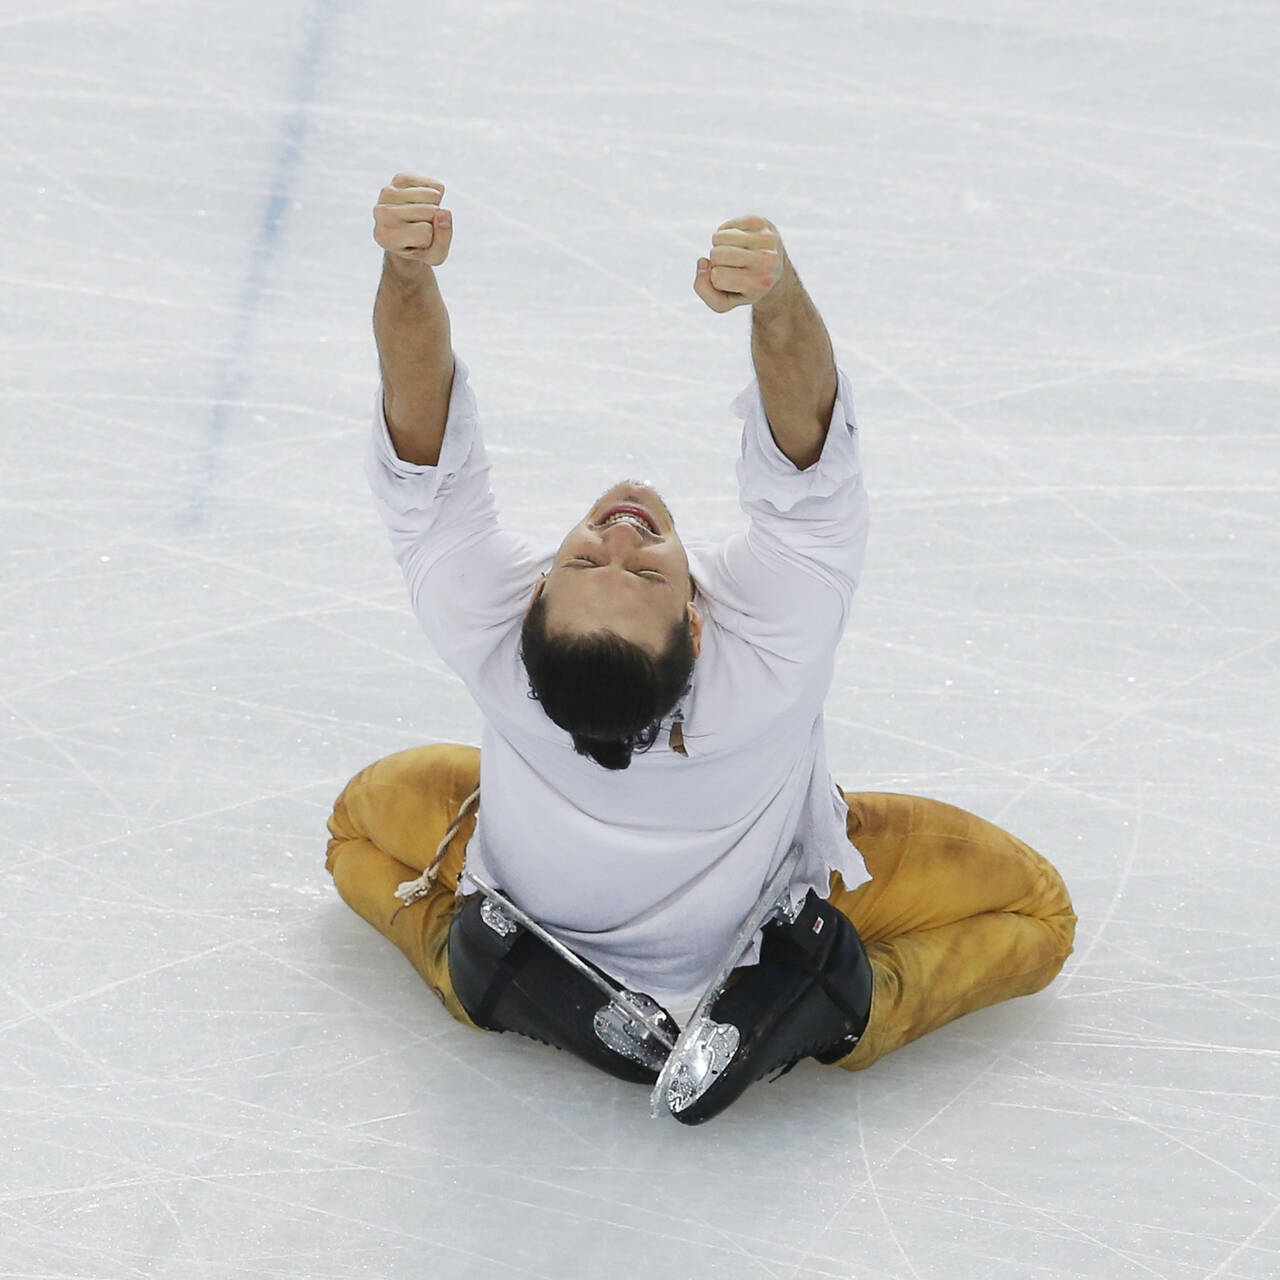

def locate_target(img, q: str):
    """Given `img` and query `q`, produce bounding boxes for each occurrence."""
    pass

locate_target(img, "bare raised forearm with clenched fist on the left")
[374,173,453,466]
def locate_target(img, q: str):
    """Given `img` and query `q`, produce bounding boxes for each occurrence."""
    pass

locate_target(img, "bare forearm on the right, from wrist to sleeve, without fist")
[751,262,837,471]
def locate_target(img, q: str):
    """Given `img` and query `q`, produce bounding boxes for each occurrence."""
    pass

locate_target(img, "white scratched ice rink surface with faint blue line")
[0,0,1280,1280]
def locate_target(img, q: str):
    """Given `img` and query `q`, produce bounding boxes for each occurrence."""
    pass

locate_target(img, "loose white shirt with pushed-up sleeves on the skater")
[367,361,869,1006]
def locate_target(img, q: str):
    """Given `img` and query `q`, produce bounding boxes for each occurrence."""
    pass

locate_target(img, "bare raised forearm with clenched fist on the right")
[694,216,836,471]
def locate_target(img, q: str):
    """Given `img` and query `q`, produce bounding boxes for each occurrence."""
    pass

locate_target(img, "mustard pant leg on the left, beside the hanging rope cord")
[325,742,480,1027]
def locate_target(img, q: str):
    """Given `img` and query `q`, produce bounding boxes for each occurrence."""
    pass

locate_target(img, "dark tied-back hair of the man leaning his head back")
[520,595,694,769]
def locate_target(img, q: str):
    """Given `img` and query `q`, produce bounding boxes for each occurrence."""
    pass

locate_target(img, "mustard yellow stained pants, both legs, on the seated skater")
[326,744,1075,1071]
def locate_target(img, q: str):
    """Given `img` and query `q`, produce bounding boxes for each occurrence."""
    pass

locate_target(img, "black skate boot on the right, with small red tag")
[669,890,872,1124]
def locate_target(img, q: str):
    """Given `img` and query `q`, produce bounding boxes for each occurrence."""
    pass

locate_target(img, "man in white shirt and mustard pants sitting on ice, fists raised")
[328,175,1075,1123]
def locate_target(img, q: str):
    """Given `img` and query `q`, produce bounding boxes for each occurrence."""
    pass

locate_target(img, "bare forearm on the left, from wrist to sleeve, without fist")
[374,253,453,466]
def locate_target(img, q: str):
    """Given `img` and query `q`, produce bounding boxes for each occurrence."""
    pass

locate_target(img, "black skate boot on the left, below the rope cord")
[449,893,680,1084]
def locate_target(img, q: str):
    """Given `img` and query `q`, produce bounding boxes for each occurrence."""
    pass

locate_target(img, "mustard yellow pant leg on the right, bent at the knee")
[831,792,1075,1071]
